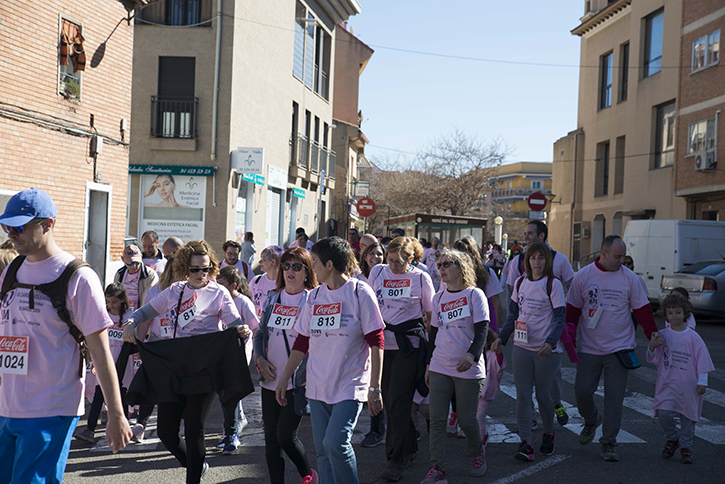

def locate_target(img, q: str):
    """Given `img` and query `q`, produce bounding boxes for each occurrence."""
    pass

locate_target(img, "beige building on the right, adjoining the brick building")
[549,0,686,260]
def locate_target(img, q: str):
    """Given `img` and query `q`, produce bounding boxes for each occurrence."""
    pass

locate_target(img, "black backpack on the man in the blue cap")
[0,255,90,377]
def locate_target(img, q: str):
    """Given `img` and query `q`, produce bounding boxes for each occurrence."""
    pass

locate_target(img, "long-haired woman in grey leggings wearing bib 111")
[491,242,566,462]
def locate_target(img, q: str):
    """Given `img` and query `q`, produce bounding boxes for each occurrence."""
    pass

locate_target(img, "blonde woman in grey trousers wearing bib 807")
[422,249,489,484]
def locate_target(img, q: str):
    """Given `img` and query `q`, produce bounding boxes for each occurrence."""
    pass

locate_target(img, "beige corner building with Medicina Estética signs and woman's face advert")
[128,0,360,266]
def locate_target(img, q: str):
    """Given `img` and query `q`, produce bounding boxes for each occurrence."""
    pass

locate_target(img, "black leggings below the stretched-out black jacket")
[158,392,214,484]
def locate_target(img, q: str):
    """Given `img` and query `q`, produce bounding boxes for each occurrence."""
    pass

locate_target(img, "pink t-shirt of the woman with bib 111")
[511,277,566,351]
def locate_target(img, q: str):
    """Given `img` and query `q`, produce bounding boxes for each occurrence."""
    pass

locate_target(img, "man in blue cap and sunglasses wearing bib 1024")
[0,188,131,483]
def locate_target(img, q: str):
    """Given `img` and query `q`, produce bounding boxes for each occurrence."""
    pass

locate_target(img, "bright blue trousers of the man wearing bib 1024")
[0,417,79,484]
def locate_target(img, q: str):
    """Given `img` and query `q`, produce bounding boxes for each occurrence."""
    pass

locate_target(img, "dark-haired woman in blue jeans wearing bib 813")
[276,237,384,484]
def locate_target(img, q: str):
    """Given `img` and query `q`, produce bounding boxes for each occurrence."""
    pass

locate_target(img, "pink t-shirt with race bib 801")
[368,264,435,350]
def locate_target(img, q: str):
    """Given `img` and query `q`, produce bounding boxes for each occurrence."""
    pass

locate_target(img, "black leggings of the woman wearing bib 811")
[262,388,312,484]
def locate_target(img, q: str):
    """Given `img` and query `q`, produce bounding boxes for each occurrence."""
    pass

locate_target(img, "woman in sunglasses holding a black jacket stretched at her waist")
[123,240,251,484]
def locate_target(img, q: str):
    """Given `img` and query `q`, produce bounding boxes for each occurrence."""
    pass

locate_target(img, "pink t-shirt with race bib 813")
[295,279,385,405]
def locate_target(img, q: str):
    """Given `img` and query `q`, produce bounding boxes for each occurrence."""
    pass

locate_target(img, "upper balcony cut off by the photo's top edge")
[136,0,212,27]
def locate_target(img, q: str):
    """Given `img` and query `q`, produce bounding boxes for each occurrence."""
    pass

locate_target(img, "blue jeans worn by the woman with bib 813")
[310,399,362,484]
